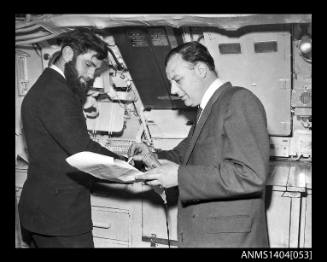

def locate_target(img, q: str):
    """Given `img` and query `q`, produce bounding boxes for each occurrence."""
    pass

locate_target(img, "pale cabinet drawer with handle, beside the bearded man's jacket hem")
[92,206,130,242]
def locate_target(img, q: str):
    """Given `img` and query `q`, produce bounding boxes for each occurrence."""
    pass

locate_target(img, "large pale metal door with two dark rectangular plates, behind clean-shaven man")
[204,28,291,136]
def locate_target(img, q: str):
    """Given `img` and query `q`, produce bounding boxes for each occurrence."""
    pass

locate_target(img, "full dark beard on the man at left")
[64,58,93,105]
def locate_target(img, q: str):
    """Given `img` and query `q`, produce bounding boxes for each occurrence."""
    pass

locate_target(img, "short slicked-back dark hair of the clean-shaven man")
[165,41,215,71]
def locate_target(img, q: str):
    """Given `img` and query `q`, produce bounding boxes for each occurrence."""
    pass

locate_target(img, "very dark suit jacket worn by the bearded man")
[19,68,125,235]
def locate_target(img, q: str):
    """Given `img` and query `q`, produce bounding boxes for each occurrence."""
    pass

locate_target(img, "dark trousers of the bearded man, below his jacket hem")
[22,228,94,248]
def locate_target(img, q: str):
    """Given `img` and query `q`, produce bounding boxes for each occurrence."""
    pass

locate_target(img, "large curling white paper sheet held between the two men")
[66,151,142,183]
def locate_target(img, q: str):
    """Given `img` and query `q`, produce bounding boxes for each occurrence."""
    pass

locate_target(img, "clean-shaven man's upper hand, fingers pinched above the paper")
[127,143,160,169]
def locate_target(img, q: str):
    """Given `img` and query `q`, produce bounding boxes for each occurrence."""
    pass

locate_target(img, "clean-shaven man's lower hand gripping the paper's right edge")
[138,160,179,188]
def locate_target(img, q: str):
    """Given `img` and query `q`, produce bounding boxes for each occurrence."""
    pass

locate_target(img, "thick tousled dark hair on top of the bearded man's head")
[58,28,108,60]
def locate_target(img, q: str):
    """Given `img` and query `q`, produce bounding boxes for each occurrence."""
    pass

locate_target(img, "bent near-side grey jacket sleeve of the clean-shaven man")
[178,91,269,202]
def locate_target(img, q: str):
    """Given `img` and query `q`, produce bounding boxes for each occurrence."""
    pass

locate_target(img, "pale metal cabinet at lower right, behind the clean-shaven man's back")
[266,161,312,248]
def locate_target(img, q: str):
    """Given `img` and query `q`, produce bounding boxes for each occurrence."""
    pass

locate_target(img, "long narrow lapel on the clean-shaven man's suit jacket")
[183,82,232,164]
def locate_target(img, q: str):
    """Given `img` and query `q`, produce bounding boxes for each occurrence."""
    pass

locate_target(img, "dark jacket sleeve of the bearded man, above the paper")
[40,87,124,158]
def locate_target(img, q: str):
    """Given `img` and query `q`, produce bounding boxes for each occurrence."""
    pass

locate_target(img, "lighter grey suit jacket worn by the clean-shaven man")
[159,83,269,247]
